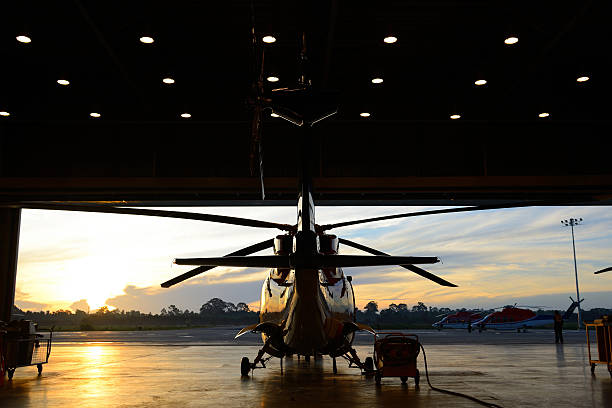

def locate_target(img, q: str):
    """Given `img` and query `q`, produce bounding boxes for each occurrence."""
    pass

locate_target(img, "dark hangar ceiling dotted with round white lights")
[0,0,612,205]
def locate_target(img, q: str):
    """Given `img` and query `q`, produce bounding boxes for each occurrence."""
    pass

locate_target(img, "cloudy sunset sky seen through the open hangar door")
[15,206,612,313]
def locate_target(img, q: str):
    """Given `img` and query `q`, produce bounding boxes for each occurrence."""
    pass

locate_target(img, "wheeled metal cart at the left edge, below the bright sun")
[0,329,53,380]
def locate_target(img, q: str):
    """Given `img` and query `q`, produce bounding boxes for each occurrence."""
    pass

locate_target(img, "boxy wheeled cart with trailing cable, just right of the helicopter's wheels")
[374,332,421,386]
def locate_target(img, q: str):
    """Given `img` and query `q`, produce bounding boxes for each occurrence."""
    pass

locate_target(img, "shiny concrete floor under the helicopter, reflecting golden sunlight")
[0,329,612,408]
